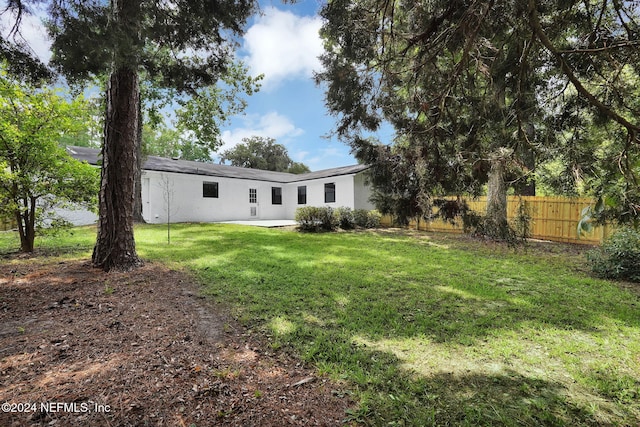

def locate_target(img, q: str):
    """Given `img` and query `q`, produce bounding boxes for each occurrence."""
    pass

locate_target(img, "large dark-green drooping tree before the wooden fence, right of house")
[318,0,539,238]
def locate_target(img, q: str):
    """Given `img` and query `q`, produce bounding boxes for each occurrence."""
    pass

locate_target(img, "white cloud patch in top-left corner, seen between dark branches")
[0,6,51,63]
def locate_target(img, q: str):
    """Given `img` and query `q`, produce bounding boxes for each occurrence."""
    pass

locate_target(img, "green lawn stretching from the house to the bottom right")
[0,224,640,426]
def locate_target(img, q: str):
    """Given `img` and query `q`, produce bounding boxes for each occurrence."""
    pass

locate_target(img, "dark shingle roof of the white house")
[67,147,368,183]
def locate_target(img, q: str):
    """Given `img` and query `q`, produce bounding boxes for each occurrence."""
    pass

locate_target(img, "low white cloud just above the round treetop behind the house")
[218,111,304,153]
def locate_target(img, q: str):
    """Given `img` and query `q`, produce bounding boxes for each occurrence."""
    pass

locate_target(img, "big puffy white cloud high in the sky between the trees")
[244,7,323,89]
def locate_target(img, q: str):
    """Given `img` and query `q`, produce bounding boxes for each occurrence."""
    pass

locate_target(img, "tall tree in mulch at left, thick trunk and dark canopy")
[42,0,257,270]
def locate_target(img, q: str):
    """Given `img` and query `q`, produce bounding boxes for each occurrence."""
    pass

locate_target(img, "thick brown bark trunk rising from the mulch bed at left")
[92,66,141,271]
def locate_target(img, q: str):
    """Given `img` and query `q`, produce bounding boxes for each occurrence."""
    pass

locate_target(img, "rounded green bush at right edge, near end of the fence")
[587,228,640,283]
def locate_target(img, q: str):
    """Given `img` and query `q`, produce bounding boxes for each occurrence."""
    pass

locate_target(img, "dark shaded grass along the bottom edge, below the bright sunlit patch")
[270,319,640,427]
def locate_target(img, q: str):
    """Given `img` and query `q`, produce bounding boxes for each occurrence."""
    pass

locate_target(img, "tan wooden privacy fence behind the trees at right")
[382,196,611,245]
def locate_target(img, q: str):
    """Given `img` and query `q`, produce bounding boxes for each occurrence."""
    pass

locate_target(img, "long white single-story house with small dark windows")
[67,147,374,223]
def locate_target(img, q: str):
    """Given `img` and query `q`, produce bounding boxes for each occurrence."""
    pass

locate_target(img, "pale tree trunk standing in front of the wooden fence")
[485,148,512,240]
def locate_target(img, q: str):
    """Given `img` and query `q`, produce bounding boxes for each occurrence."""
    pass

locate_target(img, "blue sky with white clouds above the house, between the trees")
[0,0,391,170]
